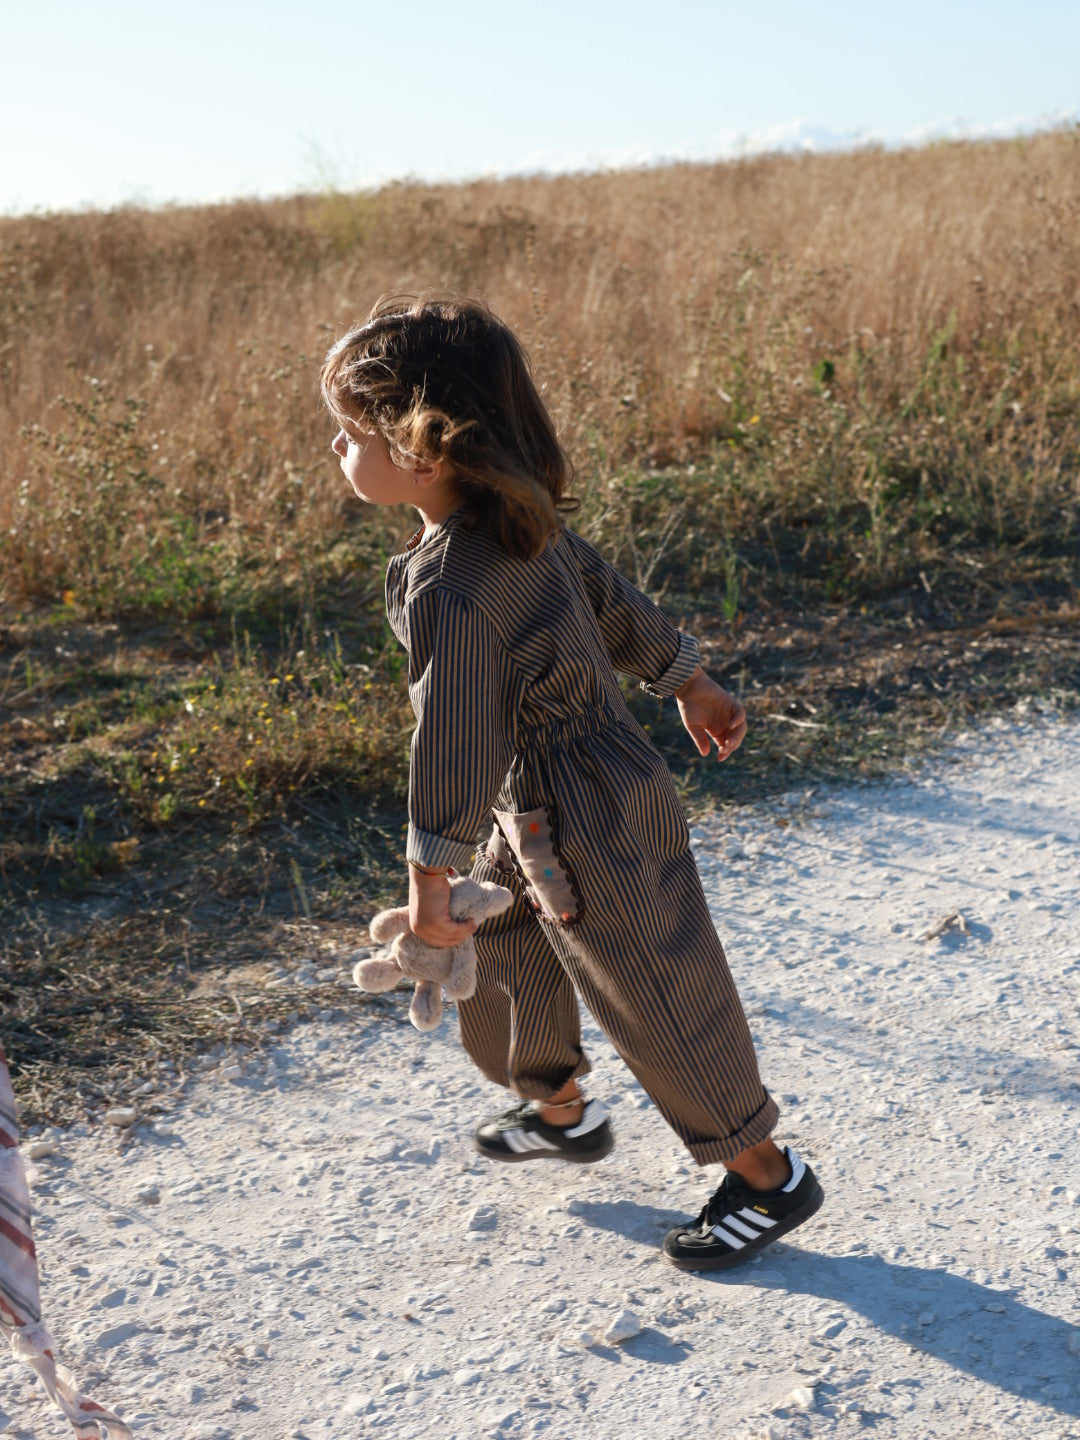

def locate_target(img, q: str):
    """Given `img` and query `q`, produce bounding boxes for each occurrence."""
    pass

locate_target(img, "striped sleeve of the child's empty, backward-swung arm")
[559,530,698,698]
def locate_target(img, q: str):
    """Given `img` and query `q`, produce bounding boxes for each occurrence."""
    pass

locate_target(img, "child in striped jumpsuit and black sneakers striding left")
[321,297,822,1270]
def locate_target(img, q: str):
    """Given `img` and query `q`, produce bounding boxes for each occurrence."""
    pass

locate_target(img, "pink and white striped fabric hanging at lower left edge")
[0,1045,134,1440]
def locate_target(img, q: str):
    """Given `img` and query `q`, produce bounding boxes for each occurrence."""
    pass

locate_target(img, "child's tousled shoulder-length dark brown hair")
[320,295,577,559]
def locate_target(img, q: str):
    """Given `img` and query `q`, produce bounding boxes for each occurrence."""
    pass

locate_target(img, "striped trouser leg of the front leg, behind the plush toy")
[458,860,590,1100]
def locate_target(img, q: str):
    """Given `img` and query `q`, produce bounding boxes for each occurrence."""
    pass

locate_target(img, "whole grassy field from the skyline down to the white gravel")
[0,130,1080,1113]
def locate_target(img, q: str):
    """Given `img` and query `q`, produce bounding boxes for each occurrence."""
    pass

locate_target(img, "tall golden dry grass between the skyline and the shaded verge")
[0,130,1080,615]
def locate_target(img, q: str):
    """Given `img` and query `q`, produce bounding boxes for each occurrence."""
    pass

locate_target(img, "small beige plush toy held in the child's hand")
[353,878,514,1030]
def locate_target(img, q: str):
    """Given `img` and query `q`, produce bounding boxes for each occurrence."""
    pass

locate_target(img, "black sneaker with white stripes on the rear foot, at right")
[664,1146,825,1270]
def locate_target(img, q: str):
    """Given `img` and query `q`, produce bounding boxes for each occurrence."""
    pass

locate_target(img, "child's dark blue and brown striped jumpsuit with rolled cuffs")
[386,511,778,1165]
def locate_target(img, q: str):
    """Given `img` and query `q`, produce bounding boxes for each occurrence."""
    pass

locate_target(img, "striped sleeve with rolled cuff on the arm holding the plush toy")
[406,588,524,871]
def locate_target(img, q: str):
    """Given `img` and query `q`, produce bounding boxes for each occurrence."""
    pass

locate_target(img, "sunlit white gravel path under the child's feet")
[0,719,1080,1440]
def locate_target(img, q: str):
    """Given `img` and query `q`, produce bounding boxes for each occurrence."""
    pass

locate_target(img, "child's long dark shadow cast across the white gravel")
[570,1200,1080,1416]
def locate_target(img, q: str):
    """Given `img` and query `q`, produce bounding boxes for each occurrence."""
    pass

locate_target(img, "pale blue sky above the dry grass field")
[0,0,1080,213]
